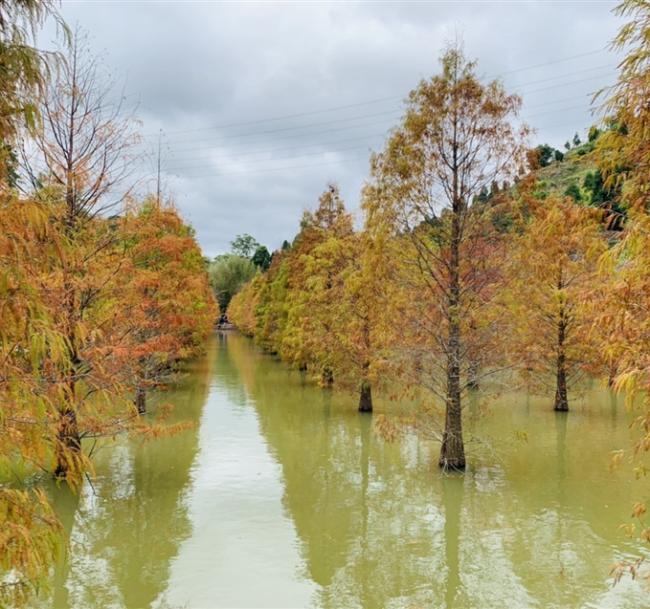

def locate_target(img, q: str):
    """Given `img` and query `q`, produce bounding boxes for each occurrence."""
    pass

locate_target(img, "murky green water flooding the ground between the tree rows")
[42,334,650,609]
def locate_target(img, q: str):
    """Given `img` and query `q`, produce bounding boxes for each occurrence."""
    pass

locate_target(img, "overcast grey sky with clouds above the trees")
[44,0,620,256]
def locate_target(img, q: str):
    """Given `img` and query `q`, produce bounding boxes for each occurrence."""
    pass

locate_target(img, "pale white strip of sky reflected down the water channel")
[159,360,312,607]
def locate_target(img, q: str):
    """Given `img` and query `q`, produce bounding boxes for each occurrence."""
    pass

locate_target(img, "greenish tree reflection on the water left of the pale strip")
[43,334,215,609]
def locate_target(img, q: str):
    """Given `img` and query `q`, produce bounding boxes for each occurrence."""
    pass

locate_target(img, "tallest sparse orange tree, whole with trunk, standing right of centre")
[365,48,527,470]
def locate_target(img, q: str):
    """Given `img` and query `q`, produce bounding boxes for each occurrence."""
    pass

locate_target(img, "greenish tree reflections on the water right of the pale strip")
[229,337,646,609]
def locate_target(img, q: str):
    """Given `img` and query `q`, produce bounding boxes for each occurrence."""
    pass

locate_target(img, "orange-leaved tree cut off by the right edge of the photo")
[595,0,650,579]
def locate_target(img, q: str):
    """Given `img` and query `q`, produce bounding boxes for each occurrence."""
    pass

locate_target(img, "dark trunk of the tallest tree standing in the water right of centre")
[438,209,465,471]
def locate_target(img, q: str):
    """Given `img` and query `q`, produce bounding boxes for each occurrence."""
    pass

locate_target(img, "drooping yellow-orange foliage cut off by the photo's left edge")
[0,0,65,606]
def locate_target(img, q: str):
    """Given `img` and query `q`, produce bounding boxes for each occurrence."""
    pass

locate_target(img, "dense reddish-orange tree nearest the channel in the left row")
[118,197,218,414]
